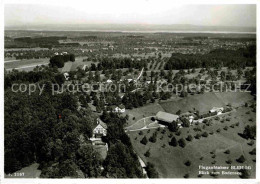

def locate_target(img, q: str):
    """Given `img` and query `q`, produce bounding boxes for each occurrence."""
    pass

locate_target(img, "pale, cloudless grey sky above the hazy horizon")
[4,0,256,27]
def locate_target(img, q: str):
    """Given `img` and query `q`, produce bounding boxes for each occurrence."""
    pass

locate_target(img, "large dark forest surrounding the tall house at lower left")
[4,67,143,178]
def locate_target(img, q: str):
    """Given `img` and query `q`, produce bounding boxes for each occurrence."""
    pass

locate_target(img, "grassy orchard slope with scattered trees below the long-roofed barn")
[128,107,256,178]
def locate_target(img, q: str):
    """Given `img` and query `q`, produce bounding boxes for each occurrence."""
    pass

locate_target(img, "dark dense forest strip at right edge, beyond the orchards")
[164,45,256,70]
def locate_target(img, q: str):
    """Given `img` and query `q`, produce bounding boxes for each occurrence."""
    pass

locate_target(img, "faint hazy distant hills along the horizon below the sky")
[5,24,256,33]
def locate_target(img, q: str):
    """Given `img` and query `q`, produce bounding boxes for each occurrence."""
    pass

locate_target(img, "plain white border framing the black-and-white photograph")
[0,0,260,184]
